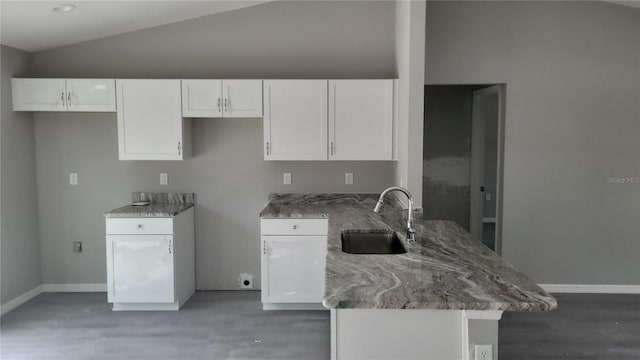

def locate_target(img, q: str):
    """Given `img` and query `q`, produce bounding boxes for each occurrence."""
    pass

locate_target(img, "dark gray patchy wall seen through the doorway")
[422,85,477,230]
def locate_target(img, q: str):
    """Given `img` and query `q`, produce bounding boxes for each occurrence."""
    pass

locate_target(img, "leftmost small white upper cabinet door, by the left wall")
[11,78,67,111]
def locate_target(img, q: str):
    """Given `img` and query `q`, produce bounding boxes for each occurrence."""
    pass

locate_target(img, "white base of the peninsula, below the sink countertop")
[331,309,502,360]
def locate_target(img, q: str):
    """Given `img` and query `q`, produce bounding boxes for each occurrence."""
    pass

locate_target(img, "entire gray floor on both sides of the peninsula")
[0,291,640,360]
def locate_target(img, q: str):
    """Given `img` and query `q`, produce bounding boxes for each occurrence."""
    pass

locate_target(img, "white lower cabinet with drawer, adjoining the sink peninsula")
[261,219,328,310]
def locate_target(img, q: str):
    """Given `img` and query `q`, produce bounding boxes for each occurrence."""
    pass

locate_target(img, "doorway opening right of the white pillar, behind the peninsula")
[422,84,506,254]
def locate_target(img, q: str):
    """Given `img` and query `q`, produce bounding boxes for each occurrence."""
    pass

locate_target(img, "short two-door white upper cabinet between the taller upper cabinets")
[182,80,262,118]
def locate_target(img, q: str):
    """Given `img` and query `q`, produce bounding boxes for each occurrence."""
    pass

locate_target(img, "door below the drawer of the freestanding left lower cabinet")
[107,235,175,303]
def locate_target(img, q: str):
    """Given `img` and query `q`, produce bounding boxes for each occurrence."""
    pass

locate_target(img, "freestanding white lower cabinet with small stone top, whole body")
[106,208,195,311]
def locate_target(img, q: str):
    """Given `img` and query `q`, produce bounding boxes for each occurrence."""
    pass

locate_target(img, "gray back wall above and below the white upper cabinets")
[32,2,395,289]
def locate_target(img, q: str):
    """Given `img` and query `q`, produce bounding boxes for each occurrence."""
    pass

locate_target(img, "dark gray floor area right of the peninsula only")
[498,294,640,360]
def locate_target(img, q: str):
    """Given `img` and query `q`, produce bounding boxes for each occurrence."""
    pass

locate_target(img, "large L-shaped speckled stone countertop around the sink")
[260,194,557,311]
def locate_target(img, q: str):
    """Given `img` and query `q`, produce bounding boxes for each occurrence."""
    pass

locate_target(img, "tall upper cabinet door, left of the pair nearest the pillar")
[263,80,327,160]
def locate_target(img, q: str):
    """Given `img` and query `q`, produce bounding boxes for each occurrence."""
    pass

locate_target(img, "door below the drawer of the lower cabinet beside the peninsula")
[262,236,327,303]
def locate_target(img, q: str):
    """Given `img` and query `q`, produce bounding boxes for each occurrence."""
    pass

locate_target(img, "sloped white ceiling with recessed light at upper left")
[0,0,266,52]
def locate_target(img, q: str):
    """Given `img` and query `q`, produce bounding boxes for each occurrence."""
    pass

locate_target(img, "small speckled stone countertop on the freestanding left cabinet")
[104,192,195,217]
